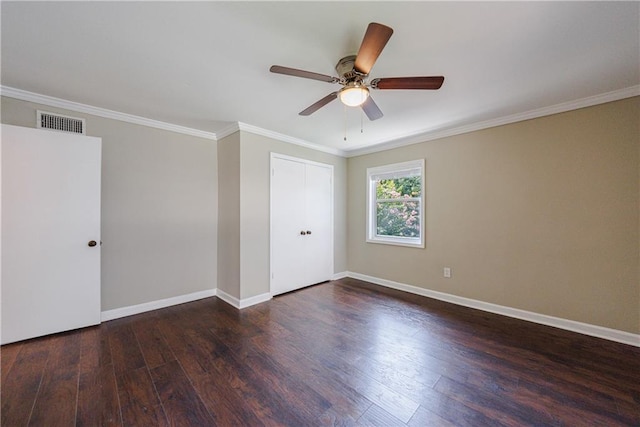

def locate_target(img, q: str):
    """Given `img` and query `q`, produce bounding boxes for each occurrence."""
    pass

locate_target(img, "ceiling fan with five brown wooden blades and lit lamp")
[269,22,444,120]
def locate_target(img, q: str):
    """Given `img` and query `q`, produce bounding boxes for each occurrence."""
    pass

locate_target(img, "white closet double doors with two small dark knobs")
[271,154,333,295]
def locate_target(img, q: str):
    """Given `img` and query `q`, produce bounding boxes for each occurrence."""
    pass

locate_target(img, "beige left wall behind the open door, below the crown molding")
[2,97,218,310]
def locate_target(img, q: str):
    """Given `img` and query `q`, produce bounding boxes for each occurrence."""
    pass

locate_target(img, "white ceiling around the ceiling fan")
[1,1,640,154]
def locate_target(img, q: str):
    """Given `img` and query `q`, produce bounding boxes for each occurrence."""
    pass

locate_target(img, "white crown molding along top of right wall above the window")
[345,85,640,157]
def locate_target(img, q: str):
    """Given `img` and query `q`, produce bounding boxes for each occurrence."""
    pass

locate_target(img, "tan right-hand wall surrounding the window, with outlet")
[347,97,640,333]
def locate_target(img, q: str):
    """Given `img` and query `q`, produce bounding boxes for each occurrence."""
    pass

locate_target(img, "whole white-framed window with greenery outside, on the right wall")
[367,159,424,248]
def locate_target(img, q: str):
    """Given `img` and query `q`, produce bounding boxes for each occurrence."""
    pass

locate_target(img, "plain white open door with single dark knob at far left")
[0,125,102,344]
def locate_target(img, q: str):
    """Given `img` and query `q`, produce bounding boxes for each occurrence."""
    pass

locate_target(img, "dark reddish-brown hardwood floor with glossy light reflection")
[0,279,640,426]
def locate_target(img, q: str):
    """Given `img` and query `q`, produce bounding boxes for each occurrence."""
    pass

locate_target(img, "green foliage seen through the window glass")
[376,176,422,237]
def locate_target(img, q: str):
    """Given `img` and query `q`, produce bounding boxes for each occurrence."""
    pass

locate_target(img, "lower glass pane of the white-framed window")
[376,200,420,237]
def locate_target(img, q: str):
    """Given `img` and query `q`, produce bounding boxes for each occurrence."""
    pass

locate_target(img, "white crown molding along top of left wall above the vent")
[0,86,218,141]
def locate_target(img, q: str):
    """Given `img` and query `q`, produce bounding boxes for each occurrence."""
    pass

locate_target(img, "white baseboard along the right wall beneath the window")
[347,271,640,347]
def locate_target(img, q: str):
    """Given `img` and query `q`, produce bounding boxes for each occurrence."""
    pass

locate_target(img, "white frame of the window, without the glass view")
[366,159,425,248]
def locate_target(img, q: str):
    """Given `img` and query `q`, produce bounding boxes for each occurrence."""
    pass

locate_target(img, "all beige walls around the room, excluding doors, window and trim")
[2,93,640,333]
